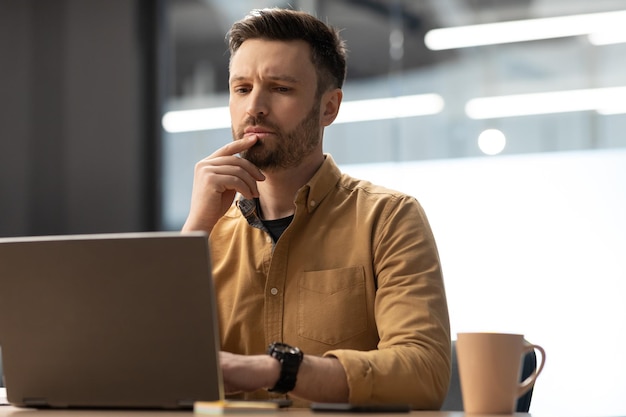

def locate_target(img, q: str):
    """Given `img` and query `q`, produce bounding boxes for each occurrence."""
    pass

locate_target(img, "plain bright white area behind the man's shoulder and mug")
[342,150,626,415]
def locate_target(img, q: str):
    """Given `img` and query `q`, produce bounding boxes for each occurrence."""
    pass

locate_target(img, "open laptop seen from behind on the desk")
[0,232,223,409]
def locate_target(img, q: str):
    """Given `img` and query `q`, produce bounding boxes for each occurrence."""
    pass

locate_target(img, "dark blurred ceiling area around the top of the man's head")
[167,0,626,97]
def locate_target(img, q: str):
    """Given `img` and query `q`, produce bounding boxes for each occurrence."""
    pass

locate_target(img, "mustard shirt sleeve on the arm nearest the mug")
[325,196,450,410]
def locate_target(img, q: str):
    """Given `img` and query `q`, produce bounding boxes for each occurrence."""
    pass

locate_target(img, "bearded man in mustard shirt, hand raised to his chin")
[183,9,450,409]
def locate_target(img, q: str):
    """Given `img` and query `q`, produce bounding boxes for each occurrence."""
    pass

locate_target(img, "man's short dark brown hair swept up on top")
[226,8,347,94]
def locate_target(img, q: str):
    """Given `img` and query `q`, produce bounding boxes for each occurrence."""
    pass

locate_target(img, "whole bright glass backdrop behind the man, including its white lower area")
[162,5,626,415]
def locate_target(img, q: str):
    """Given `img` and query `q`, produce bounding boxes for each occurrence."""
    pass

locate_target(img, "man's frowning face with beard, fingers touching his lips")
[229,39,322,170]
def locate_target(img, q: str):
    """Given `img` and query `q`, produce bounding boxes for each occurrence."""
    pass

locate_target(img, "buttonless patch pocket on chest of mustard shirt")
[298,266,367,345]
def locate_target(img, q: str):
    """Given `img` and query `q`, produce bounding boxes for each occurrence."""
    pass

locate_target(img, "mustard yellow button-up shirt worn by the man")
[210,155,450,409]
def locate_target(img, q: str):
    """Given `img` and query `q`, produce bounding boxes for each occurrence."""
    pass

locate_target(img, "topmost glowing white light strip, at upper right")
[424,10,626,51]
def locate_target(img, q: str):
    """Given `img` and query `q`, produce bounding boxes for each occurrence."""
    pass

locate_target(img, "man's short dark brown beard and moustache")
[232,104,322,171]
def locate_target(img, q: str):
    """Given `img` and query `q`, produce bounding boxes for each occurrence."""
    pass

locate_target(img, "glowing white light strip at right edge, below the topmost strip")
[465,86,626,119]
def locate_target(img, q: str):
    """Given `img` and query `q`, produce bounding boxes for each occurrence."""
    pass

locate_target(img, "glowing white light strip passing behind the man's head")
[161,94,444,133]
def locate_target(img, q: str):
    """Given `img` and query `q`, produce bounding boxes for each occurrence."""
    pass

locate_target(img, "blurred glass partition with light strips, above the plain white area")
[162,0,626,229]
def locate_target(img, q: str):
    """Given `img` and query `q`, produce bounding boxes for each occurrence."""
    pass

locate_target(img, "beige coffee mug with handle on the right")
[456,333,546,414]
